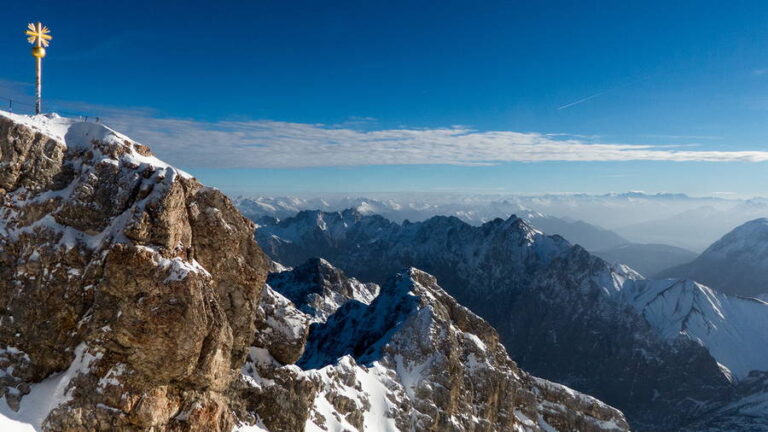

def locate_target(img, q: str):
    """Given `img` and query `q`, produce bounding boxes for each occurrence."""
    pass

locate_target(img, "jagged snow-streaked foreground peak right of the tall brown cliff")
[244,263,628,432]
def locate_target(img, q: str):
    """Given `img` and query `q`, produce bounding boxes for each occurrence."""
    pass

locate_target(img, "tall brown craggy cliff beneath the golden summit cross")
[0,116,268,431]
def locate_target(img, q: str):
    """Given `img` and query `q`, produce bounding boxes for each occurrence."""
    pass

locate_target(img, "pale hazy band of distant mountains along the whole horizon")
[235,192,768,253]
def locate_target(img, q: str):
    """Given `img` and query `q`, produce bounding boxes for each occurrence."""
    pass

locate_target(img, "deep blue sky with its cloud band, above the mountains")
[0,0,768,196]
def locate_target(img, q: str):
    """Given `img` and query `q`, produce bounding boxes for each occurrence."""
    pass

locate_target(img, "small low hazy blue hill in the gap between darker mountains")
[592,243,698,277]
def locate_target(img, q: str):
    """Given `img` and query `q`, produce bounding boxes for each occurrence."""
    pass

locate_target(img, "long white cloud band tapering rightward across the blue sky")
[91,111,768,168]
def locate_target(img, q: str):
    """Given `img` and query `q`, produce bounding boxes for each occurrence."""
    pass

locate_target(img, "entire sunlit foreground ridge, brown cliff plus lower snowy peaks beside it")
[0,113,627,432]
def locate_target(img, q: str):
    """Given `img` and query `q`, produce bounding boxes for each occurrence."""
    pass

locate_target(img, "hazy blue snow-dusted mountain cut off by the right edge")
[659,218,768,297]
